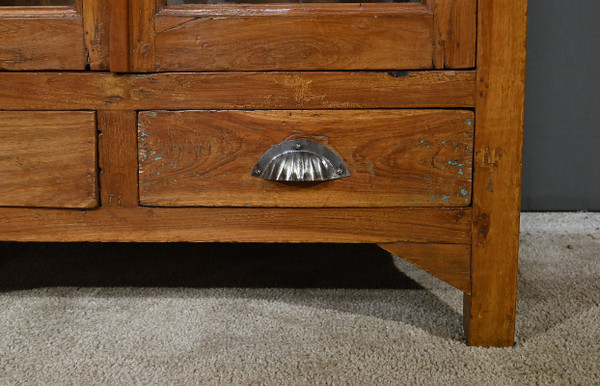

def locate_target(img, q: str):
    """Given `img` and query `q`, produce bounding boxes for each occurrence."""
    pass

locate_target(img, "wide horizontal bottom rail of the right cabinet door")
[155,8,433,71]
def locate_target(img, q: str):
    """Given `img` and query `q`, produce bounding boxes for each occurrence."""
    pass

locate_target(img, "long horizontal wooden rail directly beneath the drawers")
[0,207,471,243]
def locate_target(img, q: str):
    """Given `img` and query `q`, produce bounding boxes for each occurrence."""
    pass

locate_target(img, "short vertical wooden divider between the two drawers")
[98,110,138,207]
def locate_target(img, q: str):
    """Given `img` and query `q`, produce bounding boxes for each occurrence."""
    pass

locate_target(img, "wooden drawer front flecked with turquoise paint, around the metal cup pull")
[138,110,474,207]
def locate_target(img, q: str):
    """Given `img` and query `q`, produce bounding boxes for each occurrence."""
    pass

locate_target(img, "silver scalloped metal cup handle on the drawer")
[252,139,350,182]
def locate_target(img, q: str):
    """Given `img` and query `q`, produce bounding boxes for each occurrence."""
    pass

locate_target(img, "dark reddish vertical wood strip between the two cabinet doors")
[108,0,129,72]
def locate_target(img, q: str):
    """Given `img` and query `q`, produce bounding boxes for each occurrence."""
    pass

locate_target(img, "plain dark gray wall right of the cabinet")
[522,0,600,211]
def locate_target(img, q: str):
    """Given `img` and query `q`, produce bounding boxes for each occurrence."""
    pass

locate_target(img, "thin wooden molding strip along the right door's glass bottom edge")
[157,3,431,17]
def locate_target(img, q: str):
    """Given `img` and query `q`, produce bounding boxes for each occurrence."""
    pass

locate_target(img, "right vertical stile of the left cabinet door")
[83,0,110,71]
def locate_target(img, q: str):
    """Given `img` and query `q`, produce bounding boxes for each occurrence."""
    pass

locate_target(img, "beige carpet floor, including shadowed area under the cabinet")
[0,213,600,385]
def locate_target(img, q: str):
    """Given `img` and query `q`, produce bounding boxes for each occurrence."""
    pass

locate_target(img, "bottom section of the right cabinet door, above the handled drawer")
[125,0,476,72]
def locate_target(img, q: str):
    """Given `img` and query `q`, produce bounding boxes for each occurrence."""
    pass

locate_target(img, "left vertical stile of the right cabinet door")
[129,0,156,72]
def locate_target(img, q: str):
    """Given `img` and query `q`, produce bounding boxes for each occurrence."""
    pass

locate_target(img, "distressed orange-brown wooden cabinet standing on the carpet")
[0,0,527,346]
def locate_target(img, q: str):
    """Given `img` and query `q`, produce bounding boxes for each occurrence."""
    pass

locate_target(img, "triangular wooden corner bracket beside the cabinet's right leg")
[379,243,471,294]
